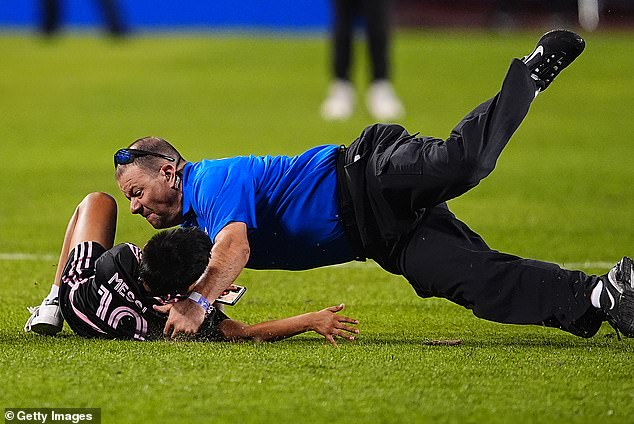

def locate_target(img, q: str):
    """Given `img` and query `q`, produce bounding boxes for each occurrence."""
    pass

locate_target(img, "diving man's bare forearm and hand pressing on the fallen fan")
[154,222,250,337]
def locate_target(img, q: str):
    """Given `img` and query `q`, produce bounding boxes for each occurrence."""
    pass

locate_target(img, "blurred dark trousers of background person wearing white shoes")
[332,0,390,80]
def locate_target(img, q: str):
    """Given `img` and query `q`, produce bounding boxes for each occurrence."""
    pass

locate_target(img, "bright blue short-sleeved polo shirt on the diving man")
[183,145,354,270]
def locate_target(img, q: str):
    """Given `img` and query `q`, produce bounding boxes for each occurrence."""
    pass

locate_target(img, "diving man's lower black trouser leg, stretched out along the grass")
[400,205,602,337]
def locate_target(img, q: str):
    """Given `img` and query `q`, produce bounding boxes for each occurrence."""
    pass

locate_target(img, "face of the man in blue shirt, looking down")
[117,165,183,229]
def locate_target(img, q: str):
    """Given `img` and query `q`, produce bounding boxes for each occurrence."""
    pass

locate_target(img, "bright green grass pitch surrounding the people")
[0,32,634,423]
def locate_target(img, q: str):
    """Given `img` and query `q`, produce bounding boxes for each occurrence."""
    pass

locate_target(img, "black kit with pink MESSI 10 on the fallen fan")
[59,242,227,340]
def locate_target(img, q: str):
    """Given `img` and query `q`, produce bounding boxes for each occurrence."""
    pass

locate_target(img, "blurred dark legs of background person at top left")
[40,0,127,37]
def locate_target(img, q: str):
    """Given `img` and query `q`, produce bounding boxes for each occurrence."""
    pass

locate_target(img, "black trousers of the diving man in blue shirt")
[344,59,601,337]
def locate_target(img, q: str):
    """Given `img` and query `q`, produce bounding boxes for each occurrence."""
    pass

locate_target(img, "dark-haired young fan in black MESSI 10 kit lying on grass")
[25,193,358,345]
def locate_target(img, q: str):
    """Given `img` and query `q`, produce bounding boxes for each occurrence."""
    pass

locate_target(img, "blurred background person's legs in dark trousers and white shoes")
[321,0,405,121]
